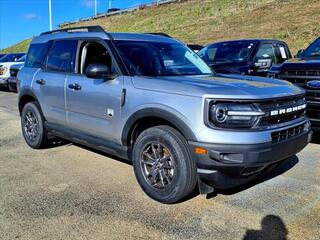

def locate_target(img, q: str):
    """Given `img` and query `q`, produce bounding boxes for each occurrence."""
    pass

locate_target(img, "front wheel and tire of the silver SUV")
[132,126,197,204]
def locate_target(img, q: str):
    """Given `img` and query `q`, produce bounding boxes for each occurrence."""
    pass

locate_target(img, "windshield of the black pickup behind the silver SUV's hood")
[198,41,256,62]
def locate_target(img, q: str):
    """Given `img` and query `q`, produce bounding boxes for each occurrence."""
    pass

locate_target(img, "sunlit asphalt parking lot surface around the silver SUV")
[0,91,320,240]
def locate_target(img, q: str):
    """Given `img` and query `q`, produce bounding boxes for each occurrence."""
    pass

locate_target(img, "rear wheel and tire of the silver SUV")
[21,102,48,149]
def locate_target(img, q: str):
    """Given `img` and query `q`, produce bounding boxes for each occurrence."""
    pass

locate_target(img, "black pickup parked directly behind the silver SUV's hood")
[198,39,291,76]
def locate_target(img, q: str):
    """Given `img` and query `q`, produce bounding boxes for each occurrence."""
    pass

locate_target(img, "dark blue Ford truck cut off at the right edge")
[269,38,320,131]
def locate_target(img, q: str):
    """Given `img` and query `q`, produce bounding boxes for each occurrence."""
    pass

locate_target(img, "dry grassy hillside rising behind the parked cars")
[1,0,320,53]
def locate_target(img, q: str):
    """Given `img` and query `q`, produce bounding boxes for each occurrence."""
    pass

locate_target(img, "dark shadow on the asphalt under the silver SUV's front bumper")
[207,155,299,199]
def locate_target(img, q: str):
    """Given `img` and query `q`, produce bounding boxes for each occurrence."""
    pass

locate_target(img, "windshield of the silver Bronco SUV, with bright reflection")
[115,40,213,76]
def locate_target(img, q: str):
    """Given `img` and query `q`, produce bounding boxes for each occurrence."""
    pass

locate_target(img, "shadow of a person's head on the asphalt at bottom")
[242,215,288,240]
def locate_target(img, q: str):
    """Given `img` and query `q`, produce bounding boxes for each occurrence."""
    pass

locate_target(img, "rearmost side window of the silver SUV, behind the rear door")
[25,42,51,68]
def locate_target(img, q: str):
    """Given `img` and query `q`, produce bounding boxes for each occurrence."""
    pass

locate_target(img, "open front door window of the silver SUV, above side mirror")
[78,42,116,74]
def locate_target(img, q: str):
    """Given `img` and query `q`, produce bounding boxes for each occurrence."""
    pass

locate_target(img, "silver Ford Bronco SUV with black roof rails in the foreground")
[18,26,311,203]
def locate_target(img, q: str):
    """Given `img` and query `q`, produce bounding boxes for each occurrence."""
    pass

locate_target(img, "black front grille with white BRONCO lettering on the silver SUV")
[259,96,306,127]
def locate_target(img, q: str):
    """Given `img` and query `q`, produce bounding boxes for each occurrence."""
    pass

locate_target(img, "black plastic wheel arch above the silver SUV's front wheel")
[121,108,196,146]
